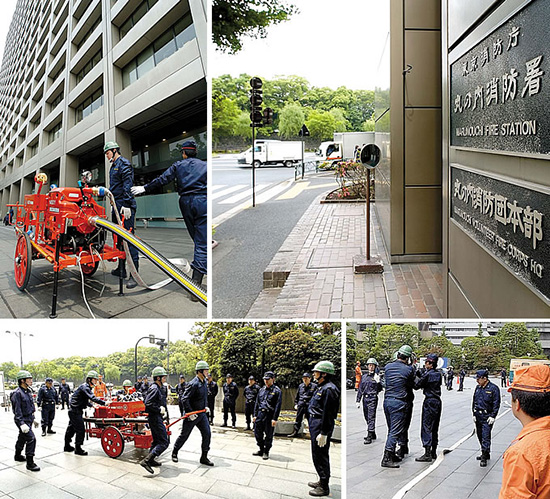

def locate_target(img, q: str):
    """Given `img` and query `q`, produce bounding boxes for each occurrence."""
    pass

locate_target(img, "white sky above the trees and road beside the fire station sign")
[212,0,389,90]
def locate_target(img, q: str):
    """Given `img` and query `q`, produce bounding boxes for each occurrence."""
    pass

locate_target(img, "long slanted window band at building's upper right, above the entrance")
[122,13,196,88]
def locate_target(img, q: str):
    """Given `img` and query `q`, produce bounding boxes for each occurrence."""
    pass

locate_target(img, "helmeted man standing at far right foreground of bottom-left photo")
[308,360,340,497]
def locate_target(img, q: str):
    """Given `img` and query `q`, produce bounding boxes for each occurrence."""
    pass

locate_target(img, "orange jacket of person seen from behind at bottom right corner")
[498,416,550,499]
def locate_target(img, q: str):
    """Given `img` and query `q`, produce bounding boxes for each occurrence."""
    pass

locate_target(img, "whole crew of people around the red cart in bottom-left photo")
[10,360,340,497]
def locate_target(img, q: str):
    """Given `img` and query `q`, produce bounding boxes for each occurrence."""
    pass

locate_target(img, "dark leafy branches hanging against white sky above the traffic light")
[212,0,298,54]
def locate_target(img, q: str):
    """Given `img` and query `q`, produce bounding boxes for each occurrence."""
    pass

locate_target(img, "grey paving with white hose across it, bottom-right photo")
[346,378,521,499]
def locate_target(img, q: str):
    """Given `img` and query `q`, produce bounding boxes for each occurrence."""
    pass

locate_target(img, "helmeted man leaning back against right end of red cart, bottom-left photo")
[139,366,170,473]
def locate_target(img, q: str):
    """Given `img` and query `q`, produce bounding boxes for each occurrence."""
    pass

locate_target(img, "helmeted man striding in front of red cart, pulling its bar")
[172,360,214,466]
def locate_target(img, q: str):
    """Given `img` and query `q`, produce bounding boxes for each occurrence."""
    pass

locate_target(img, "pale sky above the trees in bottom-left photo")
[0,319,195,365]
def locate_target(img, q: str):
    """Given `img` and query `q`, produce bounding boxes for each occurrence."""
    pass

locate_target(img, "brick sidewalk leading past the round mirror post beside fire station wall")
[247,196,443,319]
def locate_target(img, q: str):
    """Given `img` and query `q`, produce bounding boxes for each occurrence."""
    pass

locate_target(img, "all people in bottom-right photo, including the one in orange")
[356,345,550,499]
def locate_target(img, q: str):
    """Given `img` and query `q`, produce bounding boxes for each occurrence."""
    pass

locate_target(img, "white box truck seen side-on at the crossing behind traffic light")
[237,139,303,168]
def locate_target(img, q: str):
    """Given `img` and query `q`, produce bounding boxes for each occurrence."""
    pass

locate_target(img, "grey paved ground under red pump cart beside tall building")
[0,223,207,318]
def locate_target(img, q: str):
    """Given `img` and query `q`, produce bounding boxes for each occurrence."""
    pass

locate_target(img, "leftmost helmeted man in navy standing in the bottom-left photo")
[10,370,40,471]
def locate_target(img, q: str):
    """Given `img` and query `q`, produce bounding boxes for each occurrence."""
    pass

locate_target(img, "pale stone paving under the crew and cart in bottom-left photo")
[0,406,341,499]
